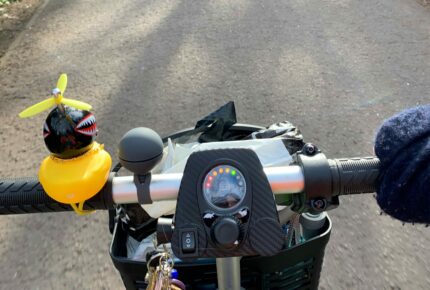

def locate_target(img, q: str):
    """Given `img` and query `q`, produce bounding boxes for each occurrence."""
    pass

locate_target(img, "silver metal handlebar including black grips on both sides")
[0,157,379,214]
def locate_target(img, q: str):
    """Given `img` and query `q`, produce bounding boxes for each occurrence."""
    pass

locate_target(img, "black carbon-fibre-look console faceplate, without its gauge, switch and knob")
[172,149,283,260]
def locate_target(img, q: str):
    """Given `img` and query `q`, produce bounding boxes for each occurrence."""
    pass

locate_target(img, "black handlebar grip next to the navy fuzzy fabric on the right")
[329,157,380,195]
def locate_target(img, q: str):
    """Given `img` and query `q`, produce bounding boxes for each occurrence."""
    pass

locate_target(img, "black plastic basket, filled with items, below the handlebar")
[110,124,331,290]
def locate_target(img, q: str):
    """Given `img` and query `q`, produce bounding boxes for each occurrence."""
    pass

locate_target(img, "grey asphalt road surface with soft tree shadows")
[0,0,430,289]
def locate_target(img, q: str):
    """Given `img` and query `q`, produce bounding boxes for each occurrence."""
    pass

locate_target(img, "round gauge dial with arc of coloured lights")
[203,165,246,209]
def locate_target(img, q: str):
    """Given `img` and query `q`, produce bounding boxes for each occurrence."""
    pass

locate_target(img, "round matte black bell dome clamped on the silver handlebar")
[118,127,163,175]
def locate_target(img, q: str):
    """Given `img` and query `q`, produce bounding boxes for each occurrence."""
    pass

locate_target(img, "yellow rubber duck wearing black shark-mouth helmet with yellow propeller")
[19,74,112,215]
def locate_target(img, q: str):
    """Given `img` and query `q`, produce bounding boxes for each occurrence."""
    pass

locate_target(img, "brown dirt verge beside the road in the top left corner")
[0,0,42,57]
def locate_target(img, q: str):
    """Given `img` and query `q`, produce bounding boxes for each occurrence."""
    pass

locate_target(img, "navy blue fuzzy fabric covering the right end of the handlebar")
[375,105,430,224]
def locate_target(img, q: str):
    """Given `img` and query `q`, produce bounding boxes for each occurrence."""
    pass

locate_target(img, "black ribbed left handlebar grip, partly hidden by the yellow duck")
[0,177,113,214]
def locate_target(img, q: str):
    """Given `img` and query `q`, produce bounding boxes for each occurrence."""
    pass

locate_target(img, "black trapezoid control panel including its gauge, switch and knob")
[172,149,284,260]
